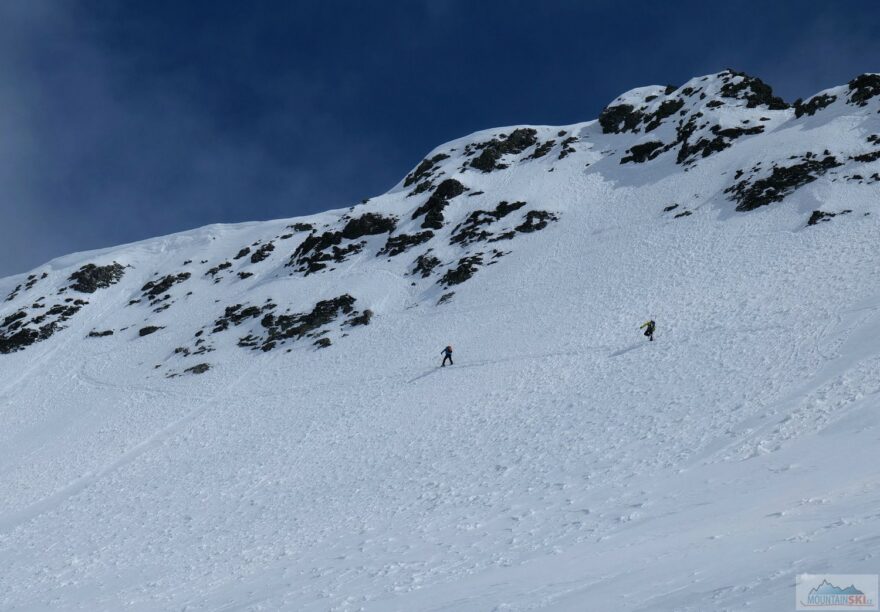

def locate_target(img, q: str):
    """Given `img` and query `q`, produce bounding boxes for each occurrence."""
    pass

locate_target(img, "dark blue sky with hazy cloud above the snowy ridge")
[0,0,880,275]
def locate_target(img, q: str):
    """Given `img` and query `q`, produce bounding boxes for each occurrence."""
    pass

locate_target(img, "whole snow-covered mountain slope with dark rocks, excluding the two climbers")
[0,71,880,611]
